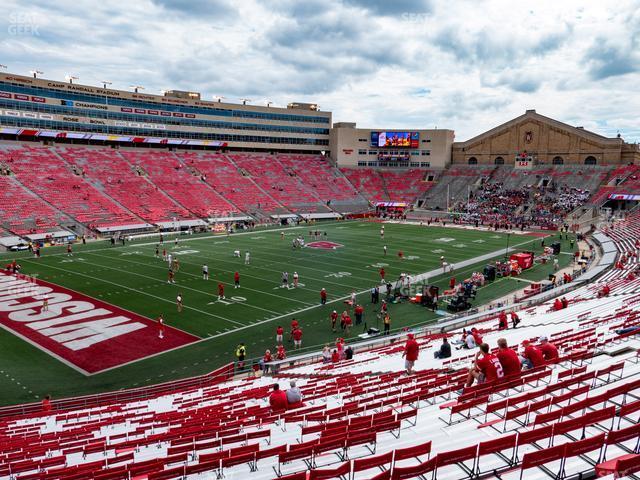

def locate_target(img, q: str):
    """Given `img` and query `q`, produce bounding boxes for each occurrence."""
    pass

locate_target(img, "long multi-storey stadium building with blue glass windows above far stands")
[0,74,331,153]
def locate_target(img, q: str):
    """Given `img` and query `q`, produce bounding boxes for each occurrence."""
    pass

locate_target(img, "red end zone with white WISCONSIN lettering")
[0,272,198,374]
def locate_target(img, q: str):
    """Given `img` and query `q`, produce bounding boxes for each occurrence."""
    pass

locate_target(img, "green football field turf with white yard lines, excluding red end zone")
[0,222,572,405]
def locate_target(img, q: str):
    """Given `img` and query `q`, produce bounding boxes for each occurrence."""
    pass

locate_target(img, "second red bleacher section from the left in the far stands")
[0,145,141,228]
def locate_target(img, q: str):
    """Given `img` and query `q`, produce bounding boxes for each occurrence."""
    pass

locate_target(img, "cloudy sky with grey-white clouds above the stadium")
[0,0,640,141]
